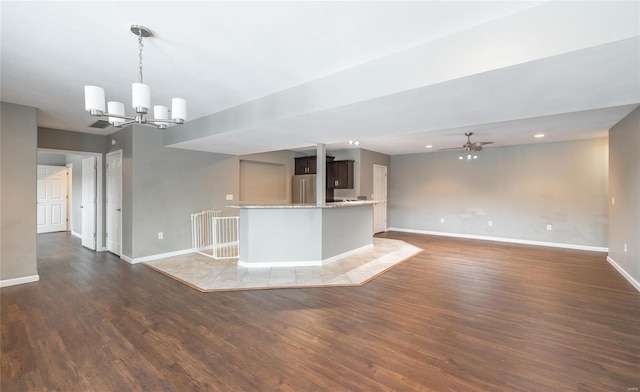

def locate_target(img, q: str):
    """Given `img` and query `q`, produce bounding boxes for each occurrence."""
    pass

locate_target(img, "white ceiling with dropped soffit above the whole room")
[0,0,640,155]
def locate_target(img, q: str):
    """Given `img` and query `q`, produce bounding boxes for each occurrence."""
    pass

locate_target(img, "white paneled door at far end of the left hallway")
[36,165,67,233]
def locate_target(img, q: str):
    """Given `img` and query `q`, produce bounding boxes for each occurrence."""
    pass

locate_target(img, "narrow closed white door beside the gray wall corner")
[107,151,122,256]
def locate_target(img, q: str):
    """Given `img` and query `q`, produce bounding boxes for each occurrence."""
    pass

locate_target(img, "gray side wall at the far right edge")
[608,108,640,289]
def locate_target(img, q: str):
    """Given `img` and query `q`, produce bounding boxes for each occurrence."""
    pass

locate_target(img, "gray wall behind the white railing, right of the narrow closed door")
[109,125,239,259]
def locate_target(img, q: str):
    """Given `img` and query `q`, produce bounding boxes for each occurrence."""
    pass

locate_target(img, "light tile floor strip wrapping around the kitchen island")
[145,238,422,292]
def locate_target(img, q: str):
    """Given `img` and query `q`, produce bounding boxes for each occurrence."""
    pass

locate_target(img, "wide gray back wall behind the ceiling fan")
[389,138,608,247]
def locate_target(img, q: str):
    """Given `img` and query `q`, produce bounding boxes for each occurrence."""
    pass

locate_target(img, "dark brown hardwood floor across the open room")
[0,232,640,392]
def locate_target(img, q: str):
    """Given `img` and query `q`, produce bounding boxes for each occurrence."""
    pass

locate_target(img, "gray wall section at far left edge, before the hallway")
[0,102,38,281]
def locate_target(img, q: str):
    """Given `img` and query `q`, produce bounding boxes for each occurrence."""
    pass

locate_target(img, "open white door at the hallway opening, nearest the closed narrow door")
[80,157,96,250]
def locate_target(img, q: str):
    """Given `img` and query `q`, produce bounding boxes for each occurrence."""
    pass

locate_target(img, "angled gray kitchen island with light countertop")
[229,201,376,268]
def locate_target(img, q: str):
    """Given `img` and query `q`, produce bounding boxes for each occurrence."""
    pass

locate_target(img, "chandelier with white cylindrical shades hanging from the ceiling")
[84,25,187,129]
